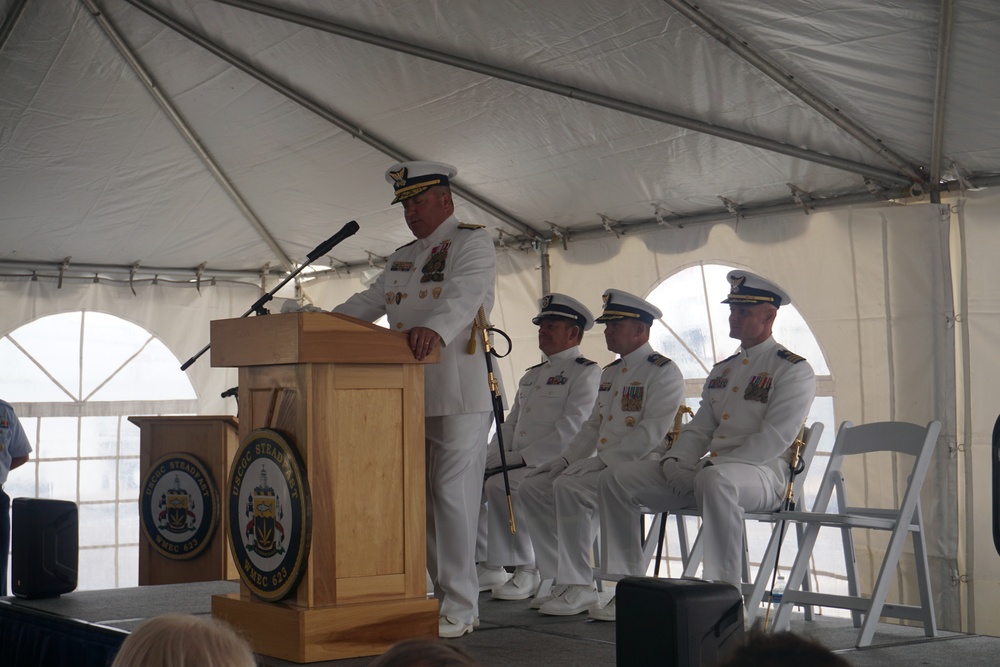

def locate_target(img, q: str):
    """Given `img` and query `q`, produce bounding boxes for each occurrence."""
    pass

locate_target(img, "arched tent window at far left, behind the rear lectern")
[0,311,197,590]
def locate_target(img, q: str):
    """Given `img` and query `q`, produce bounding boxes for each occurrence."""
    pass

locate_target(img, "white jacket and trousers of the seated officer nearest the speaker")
[479,346,601,565]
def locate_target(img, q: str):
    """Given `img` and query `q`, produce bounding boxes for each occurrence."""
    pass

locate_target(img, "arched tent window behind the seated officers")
[646,264,837,588]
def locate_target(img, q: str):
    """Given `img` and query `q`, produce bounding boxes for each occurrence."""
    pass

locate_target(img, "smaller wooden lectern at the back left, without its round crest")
[128,415,240,586]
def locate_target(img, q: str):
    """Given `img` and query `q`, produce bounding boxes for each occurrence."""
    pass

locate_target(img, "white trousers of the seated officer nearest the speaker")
[483,468,535,565]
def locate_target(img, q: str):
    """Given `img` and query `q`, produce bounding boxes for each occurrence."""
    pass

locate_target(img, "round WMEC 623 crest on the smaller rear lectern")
[139,453,219,560]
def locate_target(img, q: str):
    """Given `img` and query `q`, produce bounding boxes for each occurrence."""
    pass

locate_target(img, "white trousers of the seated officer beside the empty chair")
[600,461,781,587]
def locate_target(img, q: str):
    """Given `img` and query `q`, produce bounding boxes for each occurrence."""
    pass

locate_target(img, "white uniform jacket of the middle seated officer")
[563,343,684,467]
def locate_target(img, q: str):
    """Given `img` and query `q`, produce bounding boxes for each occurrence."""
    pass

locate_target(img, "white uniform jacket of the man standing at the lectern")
[333,216,499,417]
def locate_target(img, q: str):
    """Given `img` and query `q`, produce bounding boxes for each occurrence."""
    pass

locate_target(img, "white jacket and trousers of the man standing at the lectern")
[333,216,496,624]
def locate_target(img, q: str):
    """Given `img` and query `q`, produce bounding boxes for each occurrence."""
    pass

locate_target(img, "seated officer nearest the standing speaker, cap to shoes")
[479,294,601,600]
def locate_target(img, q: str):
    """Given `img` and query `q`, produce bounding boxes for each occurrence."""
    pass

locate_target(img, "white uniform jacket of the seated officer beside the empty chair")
[668,338,816,483]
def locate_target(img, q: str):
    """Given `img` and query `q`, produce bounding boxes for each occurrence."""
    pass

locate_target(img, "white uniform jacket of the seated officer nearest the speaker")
[490,346,601,467]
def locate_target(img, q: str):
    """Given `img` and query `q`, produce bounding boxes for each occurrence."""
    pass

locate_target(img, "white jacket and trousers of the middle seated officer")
[518,343,684,584]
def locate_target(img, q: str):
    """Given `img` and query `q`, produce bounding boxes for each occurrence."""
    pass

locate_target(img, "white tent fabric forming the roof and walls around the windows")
[0,0,1000,634]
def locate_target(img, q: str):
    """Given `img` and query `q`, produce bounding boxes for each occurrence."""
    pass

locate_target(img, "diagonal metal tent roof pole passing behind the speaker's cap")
[129,0,539,240]
